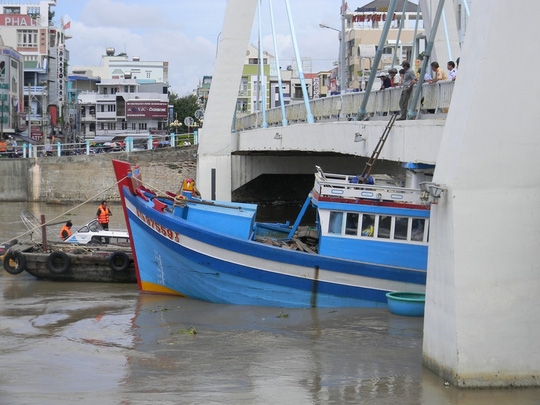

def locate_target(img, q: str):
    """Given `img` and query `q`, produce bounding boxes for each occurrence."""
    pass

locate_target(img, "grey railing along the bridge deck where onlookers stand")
[236,81,454,131]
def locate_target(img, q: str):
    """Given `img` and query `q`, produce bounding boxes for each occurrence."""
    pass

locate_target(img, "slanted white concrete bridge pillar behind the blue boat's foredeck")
[197,0,257,201]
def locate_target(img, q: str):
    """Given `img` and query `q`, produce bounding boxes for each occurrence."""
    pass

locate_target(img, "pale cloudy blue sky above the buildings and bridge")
[52,0,369,97]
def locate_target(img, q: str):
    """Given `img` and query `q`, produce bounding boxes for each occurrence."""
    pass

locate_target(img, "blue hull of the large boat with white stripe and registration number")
[122,189,426,308]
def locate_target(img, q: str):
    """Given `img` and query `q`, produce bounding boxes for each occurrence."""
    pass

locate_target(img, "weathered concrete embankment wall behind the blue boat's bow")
[0,146,197,202]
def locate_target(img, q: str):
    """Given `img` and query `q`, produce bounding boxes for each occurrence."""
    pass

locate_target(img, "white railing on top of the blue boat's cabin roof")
[313,171,425,204]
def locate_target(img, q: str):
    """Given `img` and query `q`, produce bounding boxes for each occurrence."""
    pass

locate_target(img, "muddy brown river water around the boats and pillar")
[0,203,540,405]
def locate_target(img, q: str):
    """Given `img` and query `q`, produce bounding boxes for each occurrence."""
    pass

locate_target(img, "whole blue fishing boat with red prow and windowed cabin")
[113,148,430,307]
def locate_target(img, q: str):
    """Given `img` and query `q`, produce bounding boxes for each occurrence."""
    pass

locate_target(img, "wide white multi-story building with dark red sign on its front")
[69,48,169,140]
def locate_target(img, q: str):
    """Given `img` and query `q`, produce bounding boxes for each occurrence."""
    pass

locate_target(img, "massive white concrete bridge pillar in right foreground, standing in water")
[423,0,540,388]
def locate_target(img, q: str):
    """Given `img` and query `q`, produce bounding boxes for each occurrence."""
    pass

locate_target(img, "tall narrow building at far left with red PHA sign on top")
[0,0,69,141]
